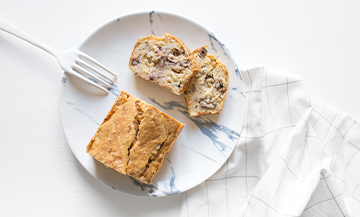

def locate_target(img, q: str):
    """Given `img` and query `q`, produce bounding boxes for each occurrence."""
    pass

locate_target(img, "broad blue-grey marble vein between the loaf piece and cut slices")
[149,97,240,157]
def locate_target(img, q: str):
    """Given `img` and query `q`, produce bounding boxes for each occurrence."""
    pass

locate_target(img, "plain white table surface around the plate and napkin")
[0,0,360,217]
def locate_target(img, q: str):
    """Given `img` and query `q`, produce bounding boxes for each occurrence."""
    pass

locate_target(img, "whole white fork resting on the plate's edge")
[0,19,116,93]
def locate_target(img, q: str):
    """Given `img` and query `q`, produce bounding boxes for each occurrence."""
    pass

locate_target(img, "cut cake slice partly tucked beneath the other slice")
[184,46,229,116]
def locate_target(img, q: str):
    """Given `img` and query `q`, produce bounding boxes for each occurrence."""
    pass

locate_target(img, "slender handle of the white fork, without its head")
[0,19,58,56]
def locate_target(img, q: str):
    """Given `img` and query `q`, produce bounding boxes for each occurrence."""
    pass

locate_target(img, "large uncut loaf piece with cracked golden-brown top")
[86,91,184,184]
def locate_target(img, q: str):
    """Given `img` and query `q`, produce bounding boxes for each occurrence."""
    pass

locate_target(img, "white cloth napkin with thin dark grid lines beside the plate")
[179,68,360,217]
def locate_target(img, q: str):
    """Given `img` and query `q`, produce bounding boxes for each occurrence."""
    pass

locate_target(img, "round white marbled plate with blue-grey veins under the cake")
[59,11,245,197]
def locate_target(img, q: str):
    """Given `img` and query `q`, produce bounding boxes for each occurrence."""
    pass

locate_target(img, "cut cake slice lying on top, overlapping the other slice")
[129,33,200,95]
